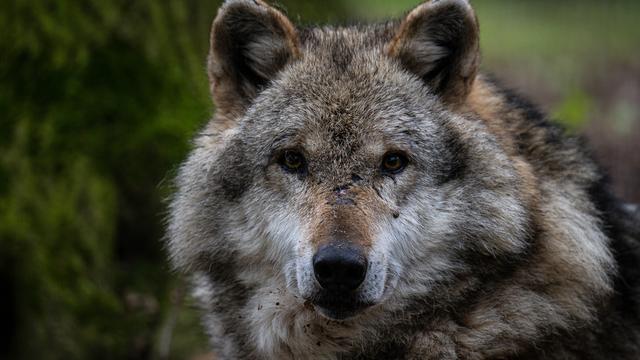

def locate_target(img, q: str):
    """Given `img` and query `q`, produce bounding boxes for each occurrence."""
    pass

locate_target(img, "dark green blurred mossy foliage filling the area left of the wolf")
[0,0,217,359]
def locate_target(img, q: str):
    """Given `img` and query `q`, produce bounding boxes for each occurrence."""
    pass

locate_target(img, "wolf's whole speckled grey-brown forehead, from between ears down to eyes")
[249,28,435,154]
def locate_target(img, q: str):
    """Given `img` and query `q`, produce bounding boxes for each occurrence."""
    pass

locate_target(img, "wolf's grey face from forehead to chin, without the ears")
[228,56,523,318]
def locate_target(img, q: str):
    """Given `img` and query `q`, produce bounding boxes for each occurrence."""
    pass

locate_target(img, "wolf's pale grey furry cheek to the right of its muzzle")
[380,159,529,303]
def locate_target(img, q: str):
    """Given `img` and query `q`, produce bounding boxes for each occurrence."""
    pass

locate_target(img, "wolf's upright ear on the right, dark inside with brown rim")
[387,0,480,105]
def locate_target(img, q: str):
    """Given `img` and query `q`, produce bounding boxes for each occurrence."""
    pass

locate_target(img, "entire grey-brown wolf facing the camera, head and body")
[166,0,640,359]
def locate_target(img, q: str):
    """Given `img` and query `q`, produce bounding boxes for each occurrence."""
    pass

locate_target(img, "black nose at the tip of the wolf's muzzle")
[313,244,367,291]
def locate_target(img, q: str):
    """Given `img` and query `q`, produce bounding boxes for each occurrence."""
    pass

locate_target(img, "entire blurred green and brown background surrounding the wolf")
[0,0,640,359]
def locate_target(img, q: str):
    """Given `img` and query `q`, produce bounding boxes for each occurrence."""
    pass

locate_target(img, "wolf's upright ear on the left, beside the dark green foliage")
[208,0,300,118]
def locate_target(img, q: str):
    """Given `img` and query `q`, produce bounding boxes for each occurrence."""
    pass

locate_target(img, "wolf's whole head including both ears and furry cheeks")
[169,0,530,320]
